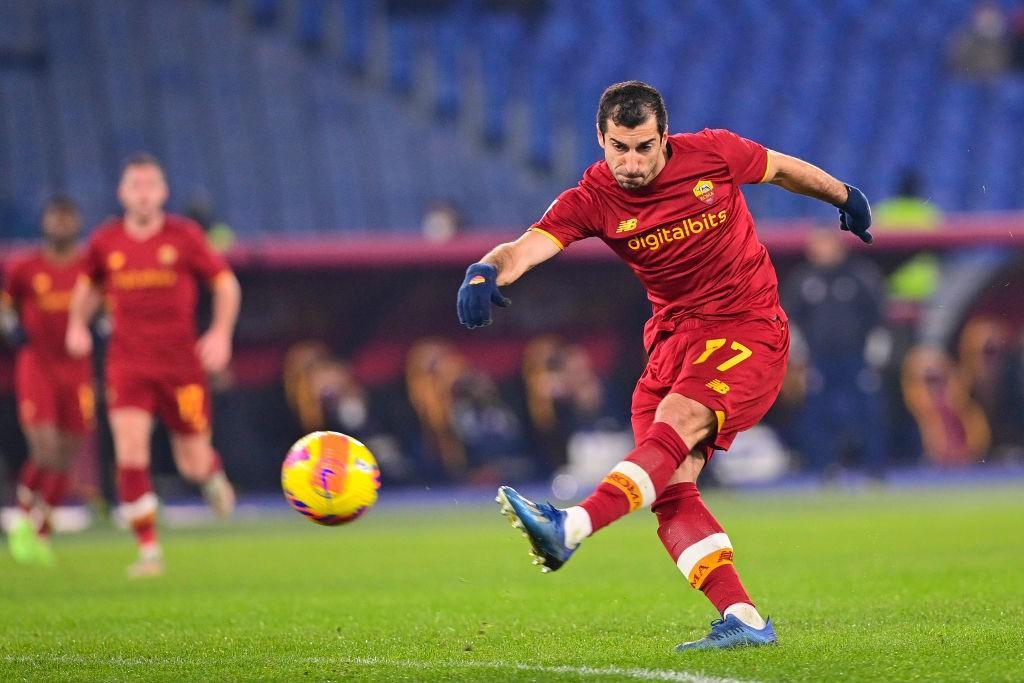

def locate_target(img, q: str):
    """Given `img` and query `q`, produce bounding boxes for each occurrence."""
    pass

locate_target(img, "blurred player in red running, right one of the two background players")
[67,155,242,577]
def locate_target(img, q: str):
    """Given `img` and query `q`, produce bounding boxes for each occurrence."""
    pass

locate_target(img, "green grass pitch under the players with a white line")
[0,487,1024,681]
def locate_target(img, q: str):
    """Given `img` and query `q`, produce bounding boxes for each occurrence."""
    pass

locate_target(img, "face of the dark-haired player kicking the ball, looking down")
[597,116,669,189]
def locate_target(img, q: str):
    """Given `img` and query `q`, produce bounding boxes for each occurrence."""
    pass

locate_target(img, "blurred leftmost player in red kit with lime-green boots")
[0,197,99,564]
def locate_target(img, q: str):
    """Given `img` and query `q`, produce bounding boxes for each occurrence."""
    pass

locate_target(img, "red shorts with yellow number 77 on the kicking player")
[633,315,790,458]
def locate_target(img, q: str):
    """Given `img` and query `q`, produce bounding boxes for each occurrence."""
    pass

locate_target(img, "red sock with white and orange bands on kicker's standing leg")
[651,481,754,613]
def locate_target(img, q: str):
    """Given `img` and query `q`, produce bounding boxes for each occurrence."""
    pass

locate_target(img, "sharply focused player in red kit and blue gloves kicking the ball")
[458,81,871,650]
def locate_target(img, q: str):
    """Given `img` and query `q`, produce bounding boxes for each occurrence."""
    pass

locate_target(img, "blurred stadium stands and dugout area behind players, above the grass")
[0,0,1024,511]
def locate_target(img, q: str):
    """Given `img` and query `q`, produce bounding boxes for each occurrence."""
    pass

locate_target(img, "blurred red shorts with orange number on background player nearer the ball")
[106,361,211,434]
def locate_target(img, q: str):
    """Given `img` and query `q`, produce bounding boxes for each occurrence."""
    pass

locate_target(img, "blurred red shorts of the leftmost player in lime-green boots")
[14,346,96,434]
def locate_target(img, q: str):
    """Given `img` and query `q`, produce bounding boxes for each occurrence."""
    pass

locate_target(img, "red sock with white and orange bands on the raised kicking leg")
[580,422,690,532]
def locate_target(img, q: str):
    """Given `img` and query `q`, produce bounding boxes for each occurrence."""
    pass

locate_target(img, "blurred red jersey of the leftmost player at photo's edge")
[3,249,88,362]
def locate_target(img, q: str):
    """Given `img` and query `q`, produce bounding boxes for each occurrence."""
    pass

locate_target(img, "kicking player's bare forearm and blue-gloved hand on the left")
[458,230,561,330]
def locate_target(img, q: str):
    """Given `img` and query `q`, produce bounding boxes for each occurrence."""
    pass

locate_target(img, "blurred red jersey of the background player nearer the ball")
[85,214,228,369]
